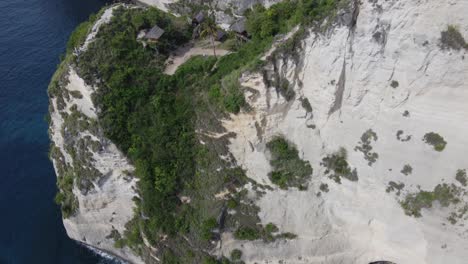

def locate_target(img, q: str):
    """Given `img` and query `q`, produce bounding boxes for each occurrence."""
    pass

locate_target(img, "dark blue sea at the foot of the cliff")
[0,0,115,264]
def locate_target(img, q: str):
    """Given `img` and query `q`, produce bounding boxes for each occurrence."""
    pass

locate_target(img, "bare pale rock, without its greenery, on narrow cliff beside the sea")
[50,6,143,263]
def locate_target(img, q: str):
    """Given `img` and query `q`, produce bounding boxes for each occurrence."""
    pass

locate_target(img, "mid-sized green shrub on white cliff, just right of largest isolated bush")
[320,148,358,184]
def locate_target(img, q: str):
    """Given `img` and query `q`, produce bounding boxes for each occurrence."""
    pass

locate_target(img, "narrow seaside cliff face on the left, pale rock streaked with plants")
[49,8,142,263]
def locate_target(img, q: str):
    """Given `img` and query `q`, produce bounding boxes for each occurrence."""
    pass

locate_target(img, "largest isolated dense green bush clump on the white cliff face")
[267,137,312,189]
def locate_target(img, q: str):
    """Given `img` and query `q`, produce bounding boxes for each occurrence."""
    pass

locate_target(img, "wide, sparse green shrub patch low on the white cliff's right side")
[400,183,460,217]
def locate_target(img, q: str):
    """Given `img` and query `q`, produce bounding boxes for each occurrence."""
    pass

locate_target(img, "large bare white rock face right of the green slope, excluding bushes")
[220,0,468,264]
